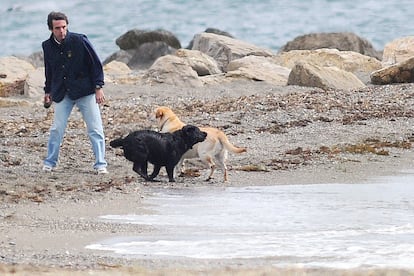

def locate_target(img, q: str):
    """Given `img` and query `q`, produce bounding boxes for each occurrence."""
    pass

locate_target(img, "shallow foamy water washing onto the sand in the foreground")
[87,172,414,268]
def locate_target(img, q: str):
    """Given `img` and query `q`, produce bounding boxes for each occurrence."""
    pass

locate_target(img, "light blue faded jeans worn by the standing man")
[44,94,107,169]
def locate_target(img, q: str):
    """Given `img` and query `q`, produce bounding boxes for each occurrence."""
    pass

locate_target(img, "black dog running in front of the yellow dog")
[110,125,207,182]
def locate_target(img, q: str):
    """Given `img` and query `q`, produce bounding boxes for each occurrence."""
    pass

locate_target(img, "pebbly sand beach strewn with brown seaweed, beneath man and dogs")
[0,81,414,275]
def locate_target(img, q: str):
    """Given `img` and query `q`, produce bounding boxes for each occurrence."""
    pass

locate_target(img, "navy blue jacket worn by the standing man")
[42,31,104,102]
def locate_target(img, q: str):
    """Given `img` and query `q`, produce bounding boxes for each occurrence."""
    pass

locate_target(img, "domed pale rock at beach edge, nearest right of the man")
[142,55,203,87]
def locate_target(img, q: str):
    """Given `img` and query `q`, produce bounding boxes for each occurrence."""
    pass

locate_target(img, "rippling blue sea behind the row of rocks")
[0,0,414,59]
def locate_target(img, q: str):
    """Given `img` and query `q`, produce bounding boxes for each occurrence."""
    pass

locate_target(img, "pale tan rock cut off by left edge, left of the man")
[0,57,35,97]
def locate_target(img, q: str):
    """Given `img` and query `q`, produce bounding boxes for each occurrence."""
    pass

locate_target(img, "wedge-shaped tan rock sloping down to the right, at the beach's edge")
[288,62,365,90]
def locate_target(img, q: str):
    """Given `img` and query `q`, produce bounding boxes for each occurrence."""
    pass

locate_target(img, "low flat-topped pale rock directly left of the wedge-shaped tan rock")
[226,56,290,85]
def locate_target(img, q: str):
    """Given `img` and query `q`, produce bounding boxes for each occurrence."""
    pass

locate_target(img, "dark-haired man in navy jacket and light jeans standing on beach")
[42,12,108,174]
